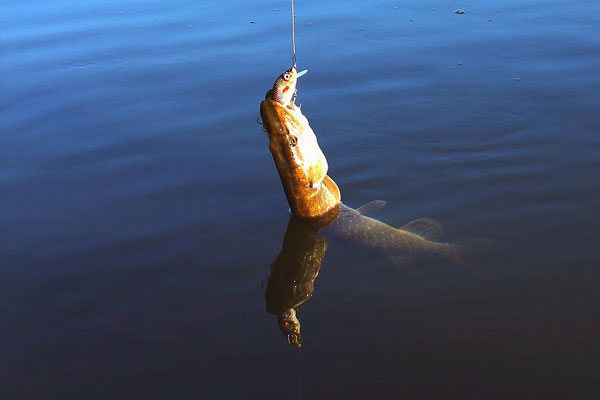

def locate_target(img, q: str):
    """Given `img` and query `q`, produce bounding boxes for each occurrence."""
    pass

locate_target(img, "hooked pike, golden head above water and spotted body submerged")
[260,68,487,265]
